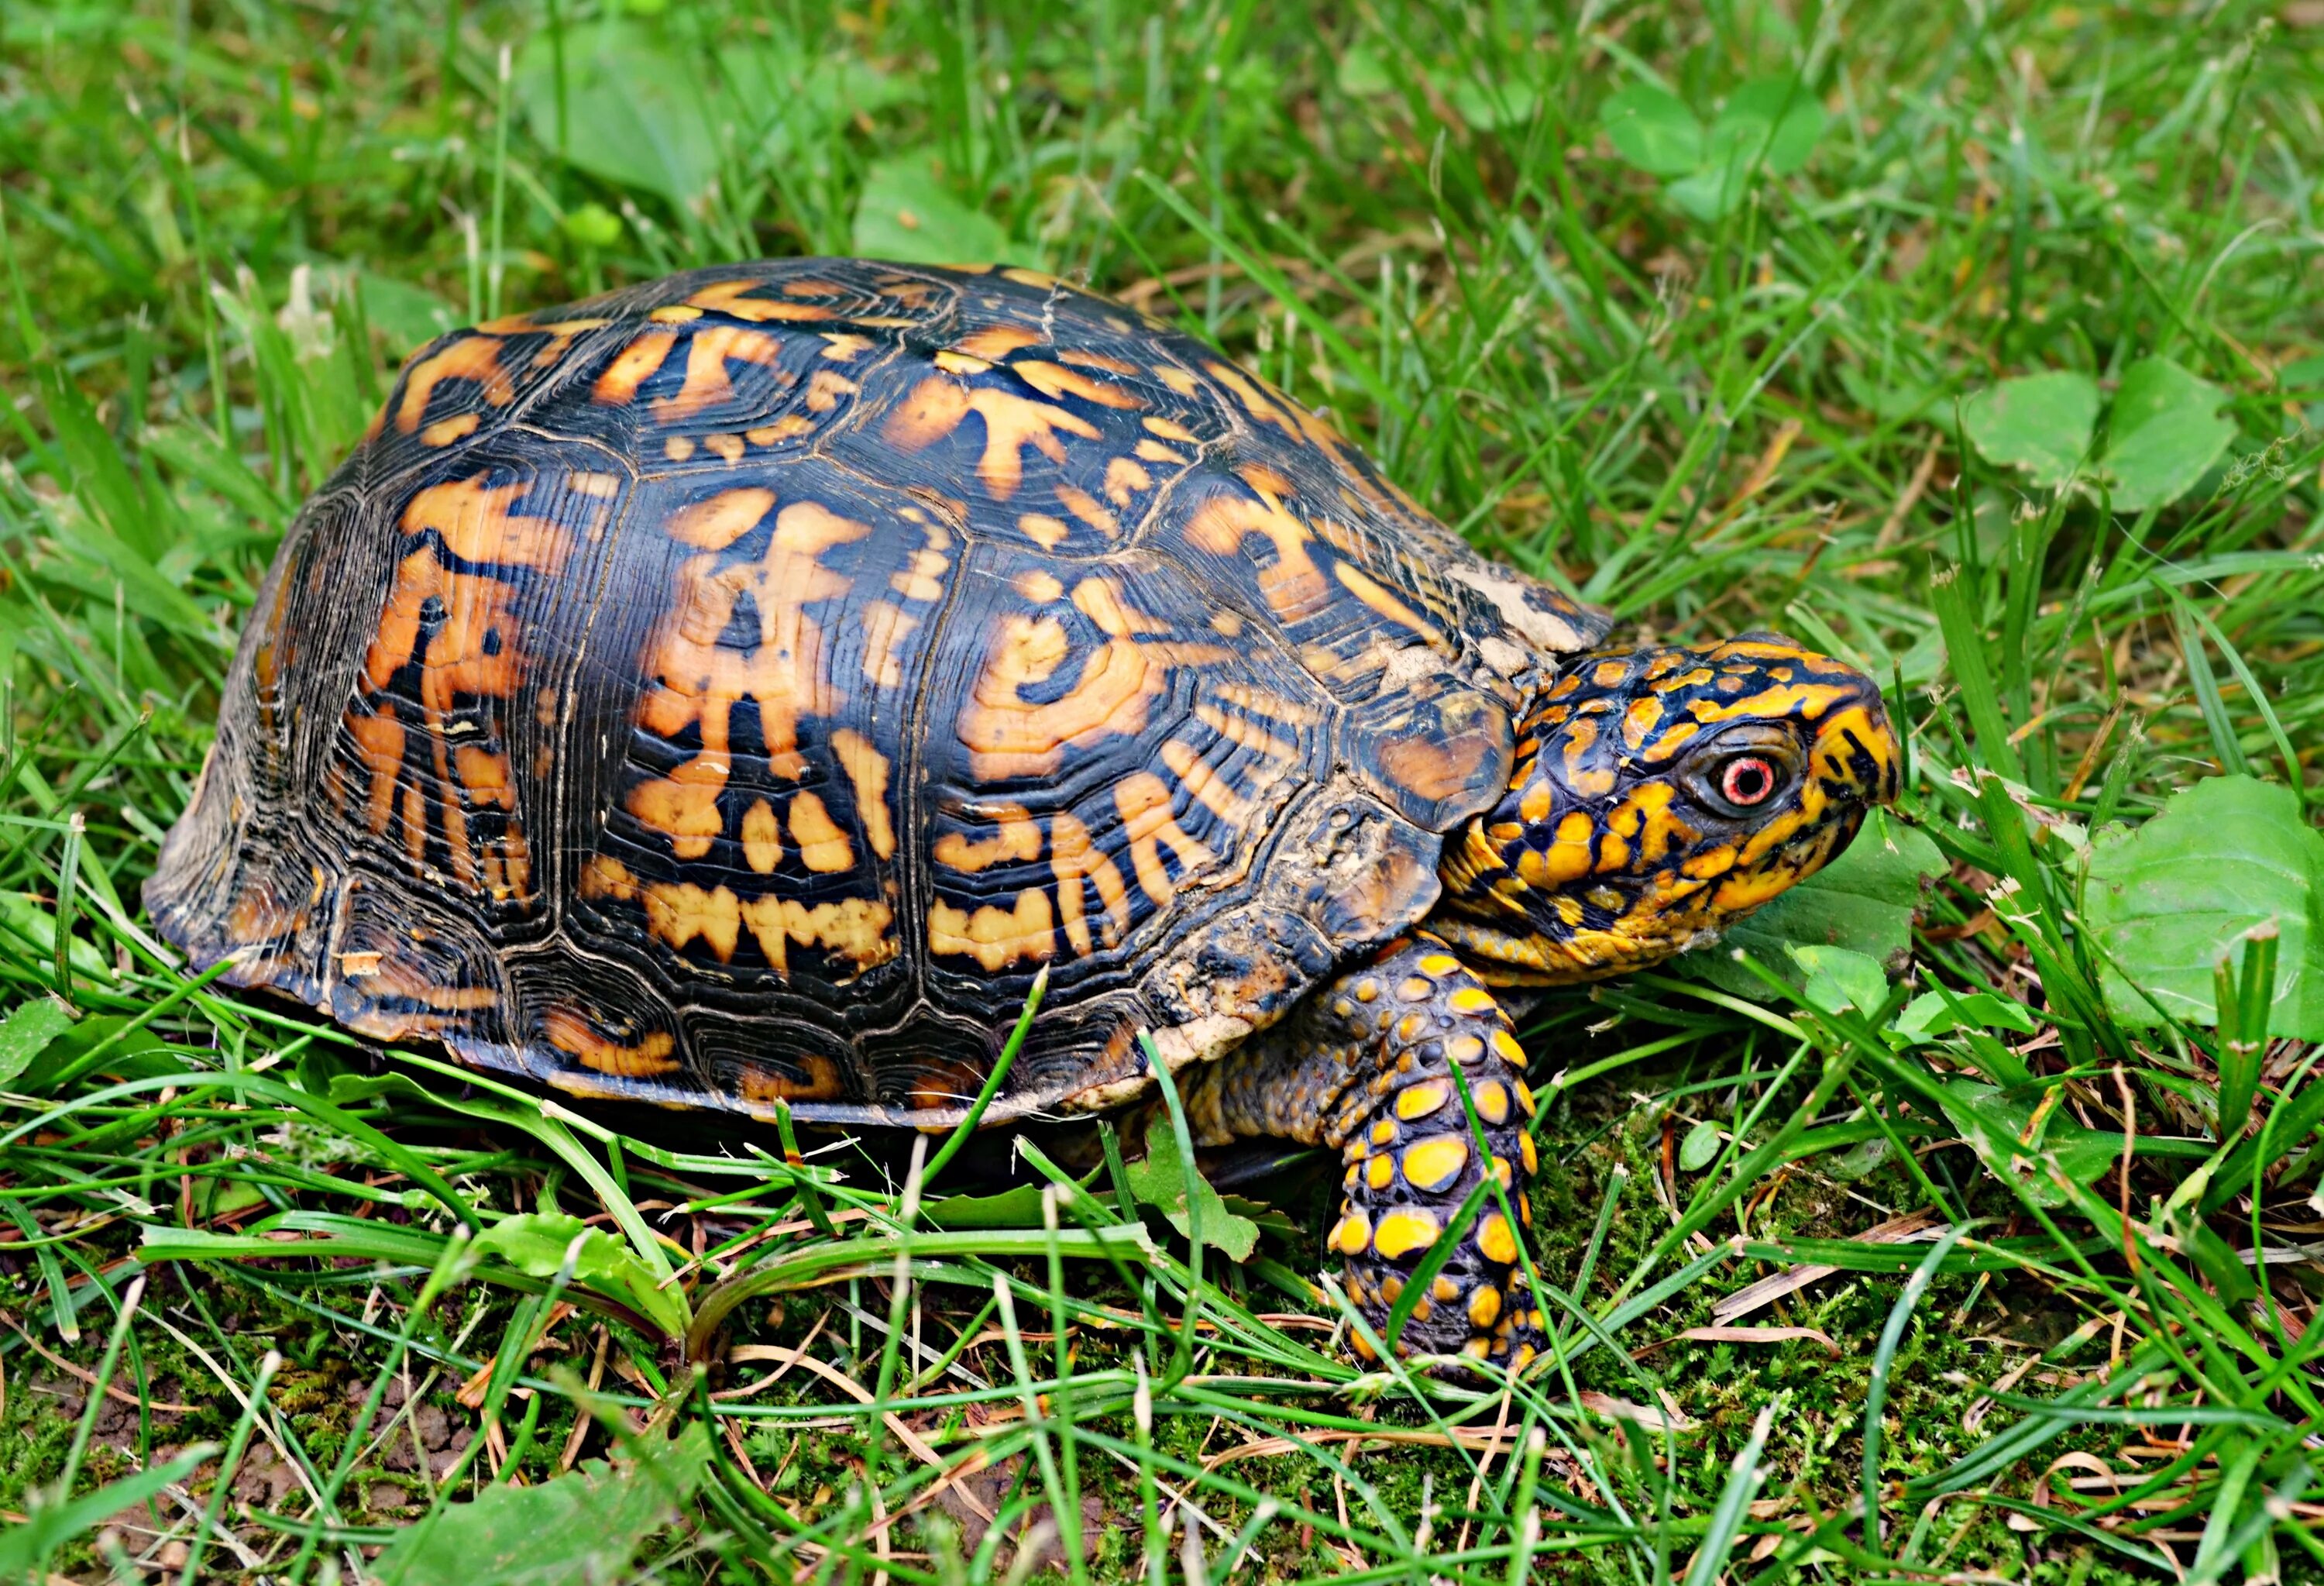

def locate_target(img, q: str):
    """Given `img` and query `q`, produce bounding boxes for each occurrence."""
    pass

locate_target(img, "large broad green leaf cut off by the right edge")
[2082,776,2324,1042]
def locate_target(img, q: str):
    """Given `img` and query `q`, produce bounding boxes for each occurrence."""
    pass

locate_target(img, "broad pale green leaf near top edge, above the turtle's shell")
[516,23,718,209]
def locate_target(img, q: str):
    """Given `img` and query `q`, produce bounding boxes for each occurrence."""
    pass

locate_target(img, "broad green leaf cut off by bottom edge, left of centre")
[376,1423,711,1586]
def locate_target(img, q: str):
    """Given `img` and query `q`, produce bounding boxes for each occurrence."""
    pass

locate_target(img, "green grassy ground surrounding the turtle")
[0,0,2324,1586]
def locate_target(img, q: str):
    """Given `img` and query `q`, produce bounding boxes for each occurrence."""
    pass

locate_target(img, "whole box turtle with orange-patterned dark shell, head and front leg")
[144,258,1899,1370]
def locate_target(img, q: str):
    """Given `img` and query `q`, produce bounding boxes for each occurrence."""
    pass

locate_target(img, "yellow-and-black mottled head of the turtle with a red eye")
[1429,632,1901,984]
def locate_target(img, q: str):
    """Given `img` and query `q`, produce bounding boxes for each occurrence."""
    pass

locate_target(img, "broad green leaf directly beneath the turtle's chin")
[1673,810,1945,1003]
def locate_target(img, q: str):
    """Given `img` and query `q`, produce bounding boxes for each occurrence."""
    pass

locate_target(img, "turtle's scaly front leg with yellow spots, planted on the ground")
[1185,937,1543,1368]
